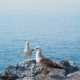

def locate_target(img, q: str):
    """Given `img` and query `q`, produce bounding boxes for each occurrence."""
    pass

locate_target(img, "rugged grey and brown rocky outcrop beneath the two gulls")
[0,60,80,80]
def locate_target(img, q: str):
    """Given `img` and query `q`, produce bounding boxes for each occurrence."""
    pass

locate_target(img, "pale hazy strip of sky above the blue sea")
[0,0,80,10]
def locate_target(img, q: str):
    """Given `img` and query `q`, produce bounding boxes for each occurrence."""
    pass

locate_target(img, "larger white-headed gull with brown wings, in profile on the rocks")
[33,47,64,74]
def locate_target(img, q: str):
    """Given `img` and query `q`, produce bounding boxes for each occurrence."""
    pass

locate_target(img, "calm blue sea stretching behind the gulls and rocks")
[0,12,80,71]
